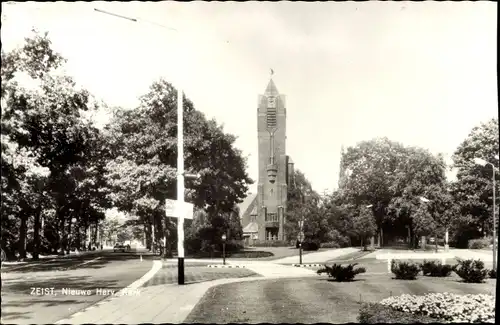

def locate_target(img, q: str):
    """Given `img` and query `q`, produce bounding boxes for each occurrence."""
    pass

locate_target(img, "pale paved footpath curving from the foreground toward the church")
[57,248,359,324]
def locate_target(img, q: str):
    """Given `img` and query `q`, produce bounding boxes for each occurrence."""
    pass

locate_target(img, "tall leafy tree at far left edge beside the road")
[2,33,110,258]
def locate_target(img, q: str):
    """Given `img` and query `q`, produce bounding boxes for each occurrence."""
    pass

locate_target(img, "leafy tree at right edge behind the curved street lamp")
[451,118,499,246]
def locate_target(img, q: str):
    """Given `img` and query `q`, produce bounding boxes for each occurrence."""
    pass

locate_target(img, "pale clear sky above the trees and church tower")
[1,1,498,192]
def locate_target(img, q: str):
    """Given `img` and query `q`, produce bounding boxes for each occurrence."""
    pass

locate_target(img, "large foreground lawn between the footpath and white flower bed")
[185,264,496,323]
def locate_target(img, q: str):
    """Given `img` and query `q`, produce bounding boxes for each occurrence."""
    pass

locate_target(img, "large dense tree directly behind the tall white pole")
[105,79,252,252]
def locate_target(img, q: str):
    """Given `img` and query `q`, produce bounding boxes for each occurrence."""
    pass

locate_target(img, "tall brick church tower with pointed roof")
[257,79,289,241]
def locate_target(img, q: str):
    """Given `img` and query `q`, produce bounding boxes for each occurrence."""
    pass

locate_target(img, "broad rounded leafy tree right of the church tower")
[335,138,446,246]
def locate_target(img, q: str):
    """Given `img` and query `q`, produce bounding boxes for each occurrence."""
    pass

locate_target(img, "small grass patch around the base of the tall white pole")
[144,263,260,287]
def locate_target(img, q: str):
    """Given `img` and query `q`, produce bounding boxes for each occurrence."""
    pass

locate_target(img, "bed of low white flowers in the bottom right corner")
[380,292,495,323]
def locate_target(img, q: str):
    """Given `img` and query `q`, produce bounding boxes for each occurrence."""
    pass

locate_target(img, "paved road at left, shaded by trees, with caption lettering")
[2,251,153,324]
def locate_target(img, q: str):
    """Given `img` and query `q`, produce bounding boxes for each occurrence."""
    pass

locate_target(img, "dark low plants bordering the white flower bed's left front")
[358,303,436,324]
